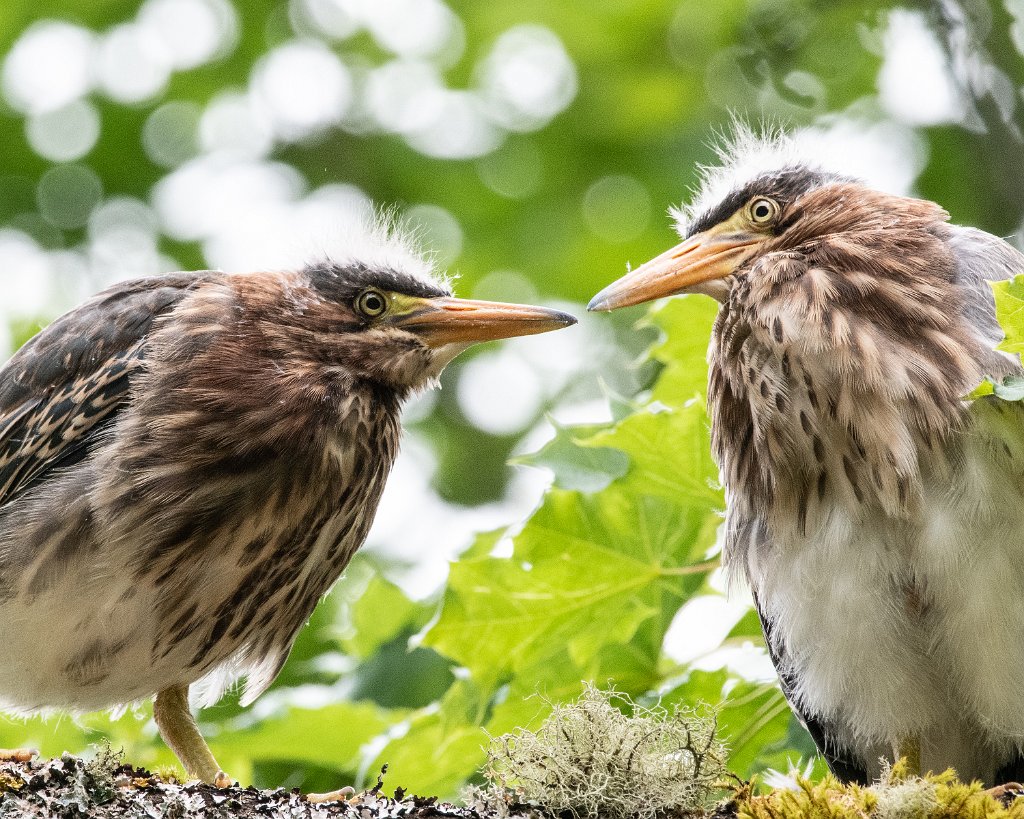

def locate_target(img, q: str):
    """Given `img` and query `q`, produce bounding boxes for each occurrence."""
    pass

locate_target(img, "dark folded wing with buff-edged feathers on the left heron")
[0,271,223,507]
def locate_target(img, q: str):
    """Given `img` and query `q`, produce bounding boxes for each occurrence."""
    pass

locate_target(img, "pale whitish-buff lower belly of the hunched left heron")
[0,522,268,712]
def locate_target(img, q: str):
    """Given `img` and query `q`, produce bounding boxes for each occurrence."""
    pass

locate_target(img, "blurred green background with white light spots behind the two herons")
[0,0,1024,795]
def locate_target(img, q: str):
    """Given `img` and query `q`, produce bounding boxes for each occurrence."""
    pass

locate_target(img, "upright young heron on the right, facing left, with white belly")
[590,133,1024,783]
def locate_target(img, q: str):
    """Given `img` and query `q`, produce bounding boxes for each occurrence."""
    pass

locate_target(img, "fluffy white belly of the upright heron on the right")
[751,451,1024,782]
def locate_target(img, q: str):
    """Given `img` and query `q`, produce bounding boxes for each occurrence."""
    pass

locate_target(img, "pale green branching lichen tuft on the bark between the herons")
[473,685,726,819]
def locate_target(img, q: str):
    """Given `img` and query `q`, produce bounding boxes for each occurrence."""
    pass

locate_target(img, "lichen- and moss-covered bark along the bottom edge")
[9,751,1024,819]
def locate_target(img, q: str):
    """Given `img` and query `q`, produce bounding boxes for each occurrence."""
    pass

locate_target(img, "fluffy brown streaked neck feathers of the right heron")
[709,185,1010,558]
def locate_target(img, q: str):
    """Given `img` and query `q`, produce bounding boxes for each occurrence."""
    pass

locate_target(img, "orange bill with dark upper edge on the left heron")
[394,297,577,347]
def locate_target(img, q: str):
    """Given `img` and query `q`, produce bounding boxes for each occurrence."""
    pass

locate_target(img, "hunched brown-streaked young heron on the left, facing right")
[0,227,575,785]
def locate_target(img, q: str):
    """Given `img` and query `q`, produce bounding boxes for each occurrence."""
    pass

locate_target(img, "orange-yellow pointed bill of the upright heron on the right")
[587,228,763,310]
